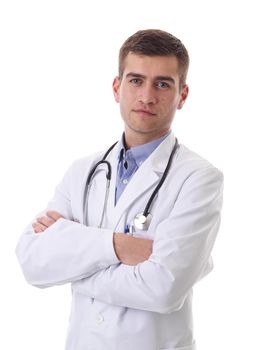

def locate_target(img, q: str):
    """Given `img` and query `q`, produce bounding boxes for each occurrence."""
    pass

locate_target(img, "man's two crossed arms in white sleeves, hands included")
[16,164,223,313]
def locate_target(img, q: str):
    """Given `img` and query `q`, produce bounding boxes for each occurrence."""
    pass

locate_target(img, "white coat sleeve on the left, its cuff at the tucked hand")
[16,161,119,288]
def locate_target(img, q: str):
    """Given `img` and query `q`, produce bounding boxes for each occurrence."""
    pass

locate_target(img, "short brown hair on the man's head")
[119,29,189,89]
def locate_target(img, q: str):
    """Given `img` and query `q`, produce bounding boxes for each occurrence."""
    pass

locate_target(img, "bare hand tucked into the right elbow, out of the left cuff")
[113,232,153,266]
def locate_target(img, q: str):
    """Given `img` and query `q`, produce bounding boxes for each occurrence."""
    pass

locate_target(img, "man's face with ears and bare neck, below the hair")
[113,53,188,147]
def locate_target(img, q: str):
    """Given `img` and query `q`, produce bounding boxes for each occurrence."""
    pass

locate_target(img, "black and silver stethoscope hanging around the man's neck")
[83,138,178,230]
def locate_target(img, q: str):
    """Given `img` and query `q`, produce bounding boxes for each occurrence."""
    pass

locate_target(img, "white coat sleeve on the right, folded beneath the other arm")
[73,168,223,313]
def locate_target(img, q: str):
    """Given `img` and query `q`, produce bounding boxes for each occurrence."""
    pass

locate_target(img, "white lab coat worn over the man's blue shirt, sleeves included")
[16,133,223,350]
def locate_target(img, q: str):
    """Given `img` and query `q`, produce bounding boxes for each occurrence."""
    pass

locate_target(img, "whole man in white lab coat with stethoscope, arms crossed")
[17,30,223,350]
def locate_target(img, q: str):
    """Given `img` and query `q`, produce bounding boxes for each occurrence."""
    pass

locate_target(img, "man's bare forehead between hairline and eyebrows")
[123,52,179,78]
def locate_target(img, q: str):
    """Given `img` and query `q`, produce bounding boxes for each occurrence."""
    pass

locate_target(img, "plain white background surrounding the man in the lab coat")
[0,0,263,350]
